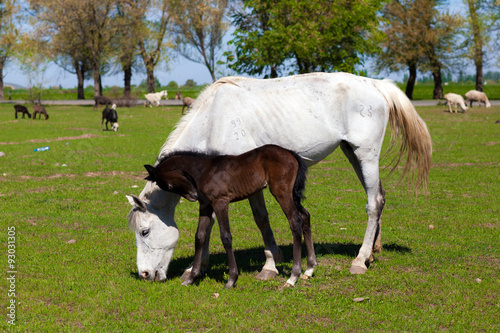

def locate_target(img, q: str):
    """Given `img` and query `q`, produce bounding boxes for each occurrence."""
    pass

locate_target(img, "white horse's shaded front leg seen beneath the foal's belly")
[248,191,283,280]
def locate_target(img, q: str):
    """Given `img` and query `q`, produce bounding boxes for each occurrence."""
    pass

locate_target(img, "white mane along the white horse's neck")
[158,77,244,158]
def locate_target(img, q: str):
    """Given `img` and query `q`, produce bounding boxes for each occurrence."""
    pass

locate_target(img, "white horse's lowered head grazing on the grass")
[127,182,179,281]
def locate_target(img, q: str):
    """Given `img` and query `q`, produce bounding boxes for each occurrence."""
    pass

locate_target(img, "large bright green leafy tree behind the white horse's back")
[230,0,381,77]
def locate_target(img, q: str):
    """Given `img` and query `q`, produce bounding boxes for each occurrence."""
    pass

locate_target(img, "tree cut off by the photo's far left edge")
[0,0,19,100]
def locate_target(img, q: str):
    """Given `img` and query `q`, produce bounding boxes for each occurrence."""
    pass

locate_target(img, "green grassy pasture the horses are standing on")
[0,105,500,332]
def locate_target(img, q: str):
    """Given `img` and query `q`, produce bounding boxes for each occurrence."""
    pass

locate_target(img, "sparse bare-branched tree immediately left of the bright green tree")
[169,0,229,81]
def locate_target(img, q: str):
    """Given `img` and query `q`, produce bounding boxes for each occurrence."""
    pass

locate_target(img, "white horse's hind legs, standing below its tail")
[340,142,385,274]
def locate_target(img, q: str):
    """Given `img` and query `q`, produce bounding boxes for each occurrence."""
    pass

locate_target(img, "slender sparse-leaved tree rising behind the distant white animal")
[139,0,171,93]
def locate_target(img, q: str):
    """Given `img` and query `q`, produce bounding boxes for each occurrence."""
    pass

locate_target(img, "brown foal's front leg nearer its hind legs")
[214,202,238,289]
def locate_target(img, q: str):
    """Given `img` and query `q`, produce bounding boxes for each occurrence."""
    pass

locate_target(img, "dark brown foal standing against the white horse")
[138,145,317,288]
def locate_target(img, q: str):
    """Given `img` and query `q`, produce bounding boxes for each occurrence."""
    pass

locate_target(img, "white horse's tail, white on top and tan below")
[374,80,432,188]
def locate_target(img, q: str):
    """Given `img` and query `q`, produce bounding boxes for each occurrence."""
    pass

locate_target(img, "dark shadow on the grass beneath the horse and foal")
[130,243,411,284]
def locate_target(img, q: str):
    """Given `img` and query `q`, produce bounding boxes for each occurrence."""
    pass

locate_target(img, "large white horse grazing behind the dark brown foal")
[127,73,432,281]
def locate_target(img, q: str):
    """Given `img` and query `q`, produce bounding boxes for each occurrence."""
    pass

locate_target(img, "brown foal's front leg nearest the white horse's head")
[182,202,213,286]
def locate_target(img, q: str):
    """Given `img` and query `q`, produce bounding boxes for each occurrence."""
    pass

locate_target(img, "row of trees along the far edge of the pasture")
[0,0,500,98]
